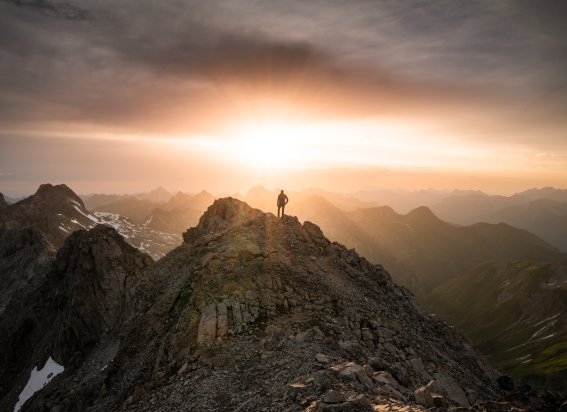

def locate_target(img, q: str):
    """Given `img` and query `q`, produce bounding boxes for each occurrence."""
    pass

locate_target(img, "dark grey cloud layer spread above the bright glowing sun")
[0,0,567,151]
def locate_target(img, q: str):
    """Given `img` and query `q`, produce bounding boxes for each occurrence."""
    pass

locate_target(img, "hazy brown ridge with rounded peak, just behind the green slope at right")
[350,206,559,290]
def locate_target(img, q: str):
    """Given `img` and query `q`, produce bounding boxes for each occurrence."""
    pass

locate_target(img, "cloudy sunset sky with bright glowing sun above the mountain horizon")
[0,0,567,196]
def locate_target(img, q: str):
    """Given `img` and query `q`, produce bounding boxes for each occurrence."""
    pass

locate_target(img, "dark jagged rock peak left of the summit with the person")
[0,225,153,410]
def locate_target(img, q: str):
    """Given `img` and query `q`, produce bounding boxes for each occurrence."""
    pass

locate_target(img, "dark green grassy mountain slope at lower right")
[424,257,567,388]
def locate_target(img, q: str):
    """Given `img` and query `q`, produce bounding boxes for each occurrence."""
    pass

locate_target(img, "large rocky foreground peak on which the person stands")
[4,198,560,412]
